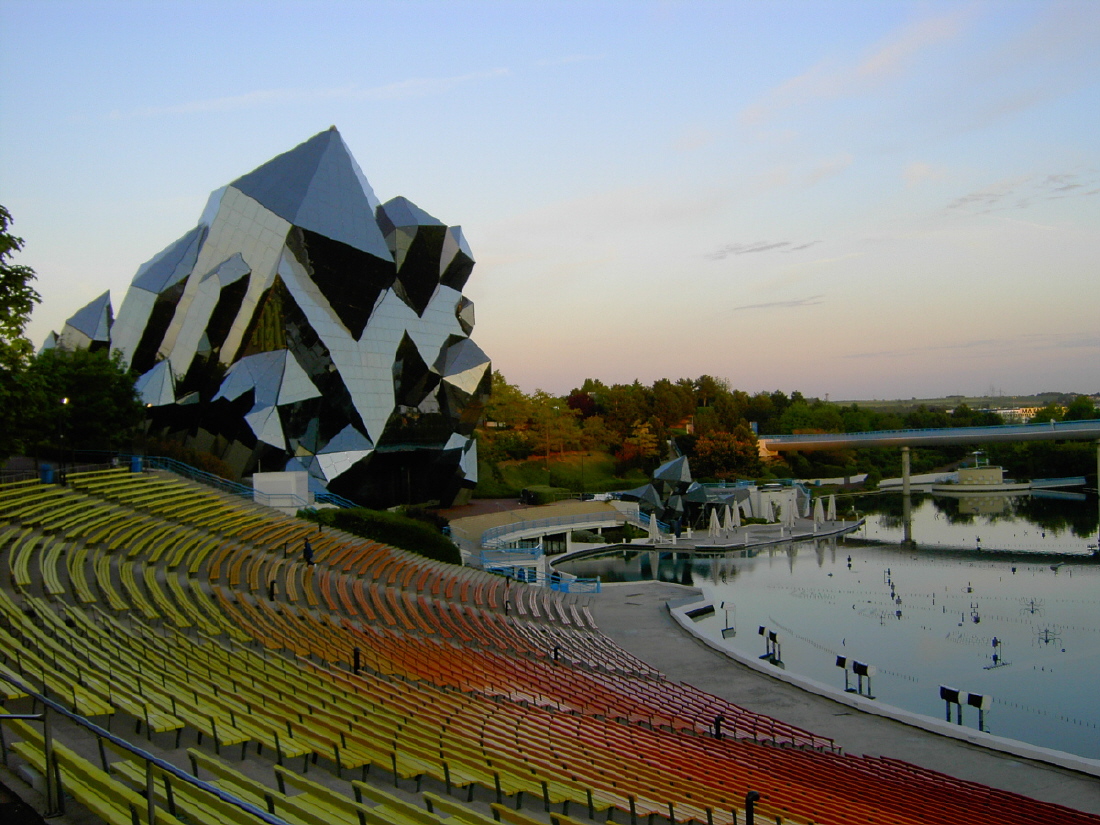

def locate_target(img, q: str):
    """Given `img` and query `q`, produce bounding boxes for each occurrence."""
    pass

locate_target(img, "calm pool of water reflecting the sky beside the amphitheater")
[562,495,1100,758]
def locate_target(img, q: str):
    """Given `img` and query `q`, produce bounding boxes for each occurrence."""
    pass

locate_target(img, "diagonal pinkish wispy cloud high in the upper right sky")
[740,10,971,124]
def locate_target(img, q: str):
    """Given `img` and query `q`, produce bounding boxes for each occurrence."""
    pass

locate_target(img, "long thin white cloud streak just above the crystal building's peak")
[108,67,509,120]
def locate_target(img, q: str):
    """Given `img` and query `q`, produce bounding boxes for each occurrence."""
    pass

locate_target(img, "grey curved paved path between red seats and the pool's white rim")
[590,582,1100,814]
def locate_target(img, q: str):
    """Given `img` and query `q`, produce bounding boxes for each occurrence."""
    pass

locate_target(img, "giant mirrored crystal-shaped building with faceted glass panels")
[47,127,491,505]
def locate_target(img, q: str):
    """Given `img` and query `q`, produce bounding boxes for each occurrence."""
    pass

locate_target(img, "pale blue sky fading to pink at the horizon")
[0,0,1100,400]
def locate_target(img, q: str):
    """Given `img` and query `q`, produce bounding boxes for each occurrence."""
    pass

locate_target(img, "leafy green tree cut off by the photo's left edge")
[0,206,42,457]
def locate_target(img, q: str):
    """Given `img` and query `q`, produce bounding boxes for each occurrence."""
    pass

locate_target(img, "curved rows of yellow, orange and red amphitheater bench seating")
[0,471,1100,825]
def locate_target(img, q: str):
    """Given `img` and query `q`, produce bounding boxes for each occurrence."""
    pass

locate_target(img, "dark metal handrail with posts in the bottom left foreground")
[0,673,287,825]
